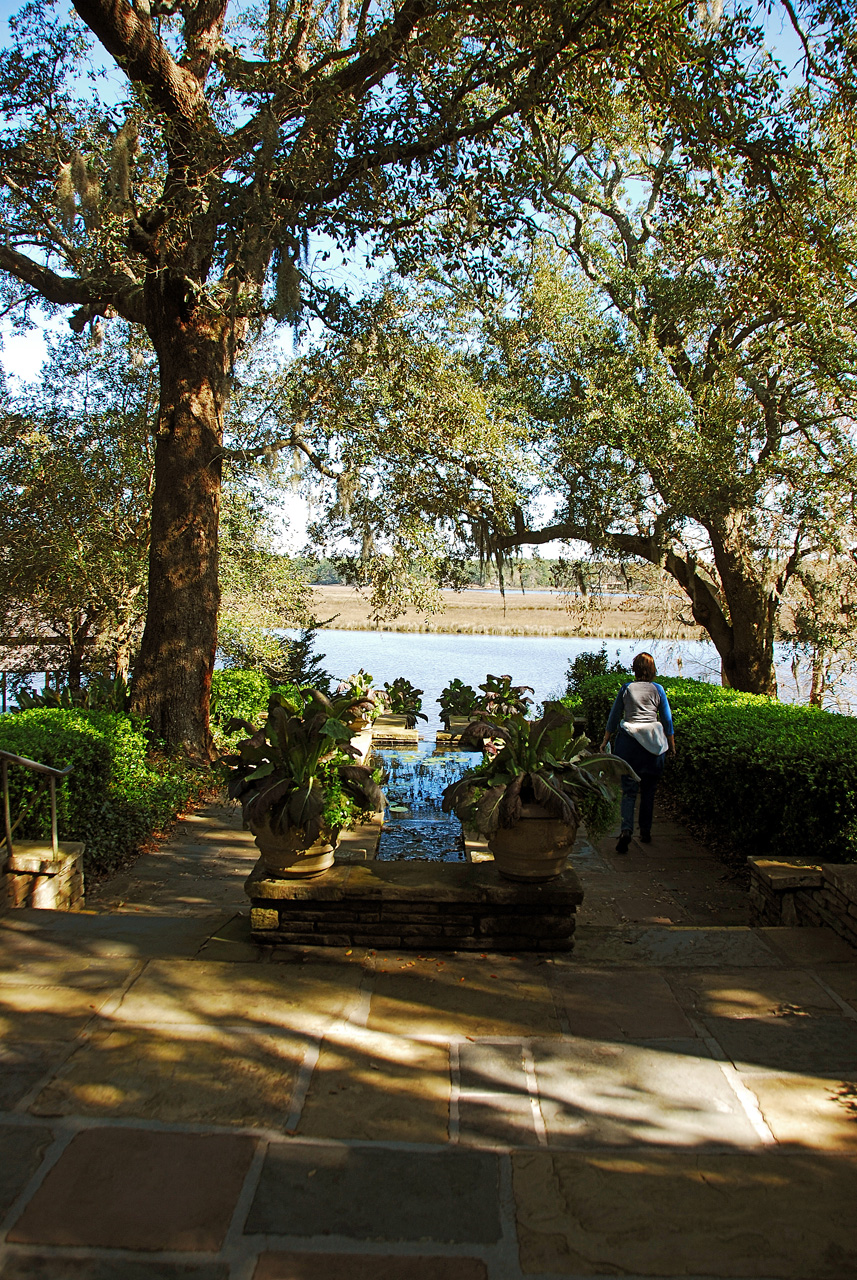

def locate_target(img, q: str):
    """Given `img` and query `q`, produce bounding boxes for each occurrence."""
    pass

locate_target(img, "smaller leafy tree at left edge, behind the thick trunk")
[0,333,157,689]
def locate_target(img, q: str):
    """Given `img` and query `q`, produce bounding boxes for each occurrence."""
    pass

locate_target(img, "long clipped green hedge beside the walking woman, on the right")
[582,675,857,863]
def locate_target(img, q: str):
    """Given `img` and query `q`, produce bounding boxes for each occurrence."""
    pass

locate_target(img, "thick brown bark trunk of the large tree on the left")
[132,275,230,760]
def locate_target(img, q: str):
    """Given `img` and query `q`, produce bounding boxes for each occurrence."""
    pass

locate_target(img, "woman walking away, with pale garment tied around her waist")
[601,653,675,854]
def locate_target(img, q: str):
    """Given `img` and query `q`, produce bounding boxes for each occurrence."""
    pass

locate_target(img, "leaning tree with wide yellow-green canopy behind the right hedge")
[269,74,857,694]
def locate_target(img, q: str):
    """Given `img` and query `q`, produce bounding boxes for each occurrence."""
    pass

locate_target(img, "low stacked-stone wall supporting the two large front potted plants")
[244,861,583,951]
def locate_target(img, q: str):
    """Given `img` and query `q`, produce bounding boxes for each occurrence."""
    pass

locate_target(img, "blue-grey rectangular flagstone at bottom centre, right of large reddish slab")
[244,1142,501,1244]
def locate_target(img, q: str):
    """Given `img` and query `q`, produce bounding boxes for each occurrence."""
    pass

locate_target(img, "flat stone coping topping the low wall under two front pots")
[244,860,583,910]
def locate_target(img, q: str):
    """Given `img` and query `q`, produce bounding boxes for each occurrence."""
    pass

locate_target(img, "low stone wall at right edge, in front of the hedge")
[748,858,857,947]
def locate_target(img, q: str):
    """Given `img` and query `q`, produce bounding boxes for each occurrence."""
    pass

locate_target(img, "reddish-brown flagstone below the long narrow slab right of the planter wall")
[553,968,693,1039]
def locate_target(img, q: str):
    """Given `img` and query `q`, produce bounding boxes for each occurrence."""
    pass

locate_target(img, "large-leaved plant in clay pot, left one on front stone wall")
[223,689,385,878]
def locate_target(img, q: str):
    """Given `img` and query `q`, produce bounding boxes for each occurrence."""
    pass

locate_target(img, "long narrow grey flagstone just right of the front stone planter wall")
[570,925,787,969]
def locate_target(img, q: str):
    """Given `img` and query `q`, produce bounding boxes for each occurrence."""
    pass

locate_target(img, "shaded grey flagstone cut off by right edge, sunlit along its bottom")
[706,1015,857,1075]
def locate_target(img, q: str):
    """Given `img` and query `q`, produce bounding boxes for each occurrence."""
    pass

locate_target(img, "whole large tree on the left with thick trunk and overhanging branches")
[0,0,848,753]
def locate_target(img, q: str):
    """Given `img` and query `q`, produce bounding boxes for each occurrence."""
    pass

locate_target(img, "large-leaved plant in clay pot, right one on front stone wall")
[443,708,633,881]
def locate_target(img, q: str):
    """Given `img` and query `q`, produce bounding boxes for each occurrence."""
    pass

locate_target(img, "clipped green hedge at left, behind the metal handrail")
[0,708,200,878]
